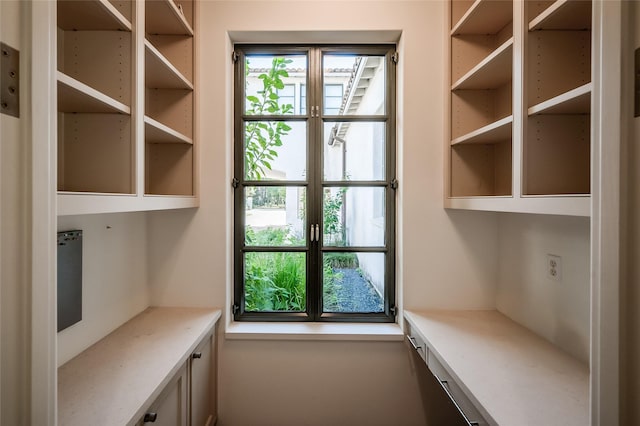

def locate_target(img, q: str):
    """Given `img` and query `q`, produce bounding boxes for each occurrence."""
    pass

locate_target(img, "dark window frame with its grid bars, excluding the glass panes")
[234,46,395,322]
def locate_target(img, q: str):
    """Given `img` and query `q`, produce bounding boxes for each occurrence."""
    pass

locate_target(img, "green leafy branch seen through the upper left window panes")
[244,57,293,180]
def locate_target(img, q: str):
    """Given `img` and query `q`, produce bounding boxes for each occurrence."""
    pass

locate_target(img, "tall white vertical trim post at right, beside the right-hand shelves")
[590,0,624,426]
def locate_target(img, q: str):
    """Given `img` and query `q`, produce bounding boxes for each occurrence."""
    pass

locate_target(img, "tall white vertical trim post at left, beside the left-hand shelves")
[31,0,57,426]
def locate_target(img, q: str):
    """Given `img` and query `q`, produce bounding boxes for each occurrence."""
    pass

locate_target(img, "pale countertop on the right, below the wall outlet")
[404,311,589,426]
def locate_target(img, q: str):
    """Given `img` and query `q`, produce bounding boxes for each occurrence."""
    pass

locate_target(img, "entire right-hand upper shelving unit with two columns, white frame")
[445,0,592,216]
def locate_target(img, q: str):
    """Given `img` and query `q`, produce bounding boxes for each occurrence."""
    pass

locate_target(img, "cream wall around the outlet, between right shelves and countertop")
[496,214,591,363]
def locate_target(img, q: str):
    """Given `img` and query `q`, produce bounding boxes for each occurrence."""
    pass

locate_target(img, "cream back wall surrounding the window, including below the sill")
[148,1,497,426]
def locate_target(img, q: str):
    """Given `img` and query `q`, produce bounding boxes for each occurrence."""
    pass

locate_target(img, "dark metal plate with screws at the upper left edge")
[0,43,20,117]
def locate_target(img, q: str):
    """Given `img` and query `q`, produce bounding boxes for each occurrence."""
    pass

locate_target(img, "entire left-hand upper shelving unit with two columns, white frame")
[57,0,198,215]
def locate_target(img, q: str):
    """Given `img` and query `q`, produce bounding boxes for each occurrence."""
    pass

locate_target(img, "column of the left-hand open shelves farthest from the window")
[57,1,135,194]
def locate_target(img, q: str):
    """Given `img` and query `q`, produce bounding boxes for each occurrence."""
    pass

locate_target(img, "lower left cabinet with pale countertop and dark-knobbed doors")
[58,307,220,426]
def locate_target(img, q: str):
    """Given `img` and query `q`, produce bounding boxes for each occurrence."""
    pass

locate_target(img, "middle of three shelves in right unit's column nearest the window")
[451,37,513,90]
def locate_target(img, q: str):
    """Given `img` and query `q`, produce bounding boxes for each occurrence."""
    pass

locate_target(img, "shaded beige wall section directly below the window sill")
[218,340,425,426]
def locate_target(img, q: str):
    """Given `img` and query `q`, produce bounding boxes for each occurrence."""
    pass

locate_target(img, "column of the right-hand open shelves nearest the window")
[448,0,514,197]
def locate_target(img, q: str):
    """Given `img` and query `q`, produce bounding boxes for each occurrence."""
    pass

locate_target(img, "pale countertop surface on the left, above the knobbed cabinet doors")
[58,308,220,426]
